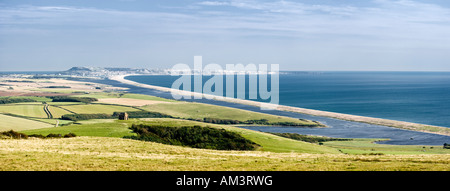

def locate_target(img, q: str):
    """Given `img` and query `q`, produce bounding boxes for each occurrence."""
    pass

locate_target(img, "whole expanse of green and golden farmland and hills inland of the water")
[0,73,450,171]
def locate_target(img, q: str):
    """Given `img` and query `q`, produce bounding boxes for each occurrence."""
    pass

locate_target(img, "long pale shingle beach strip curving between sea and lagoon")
[109,75,450,136]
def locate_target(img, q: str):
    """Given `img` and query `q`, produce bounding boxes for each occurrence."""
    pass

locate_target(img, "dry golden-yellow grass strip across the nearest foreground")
[0,137,450,171]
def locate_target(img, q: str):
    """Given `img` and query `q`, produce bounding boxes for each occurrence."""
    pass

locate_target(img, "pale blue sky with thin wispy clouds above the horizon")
[0,0,450,71]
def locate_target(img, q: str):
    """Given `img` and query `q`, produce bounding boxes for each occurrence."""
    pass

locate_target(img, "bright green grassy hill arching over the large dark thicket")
[22,118,339,153]
